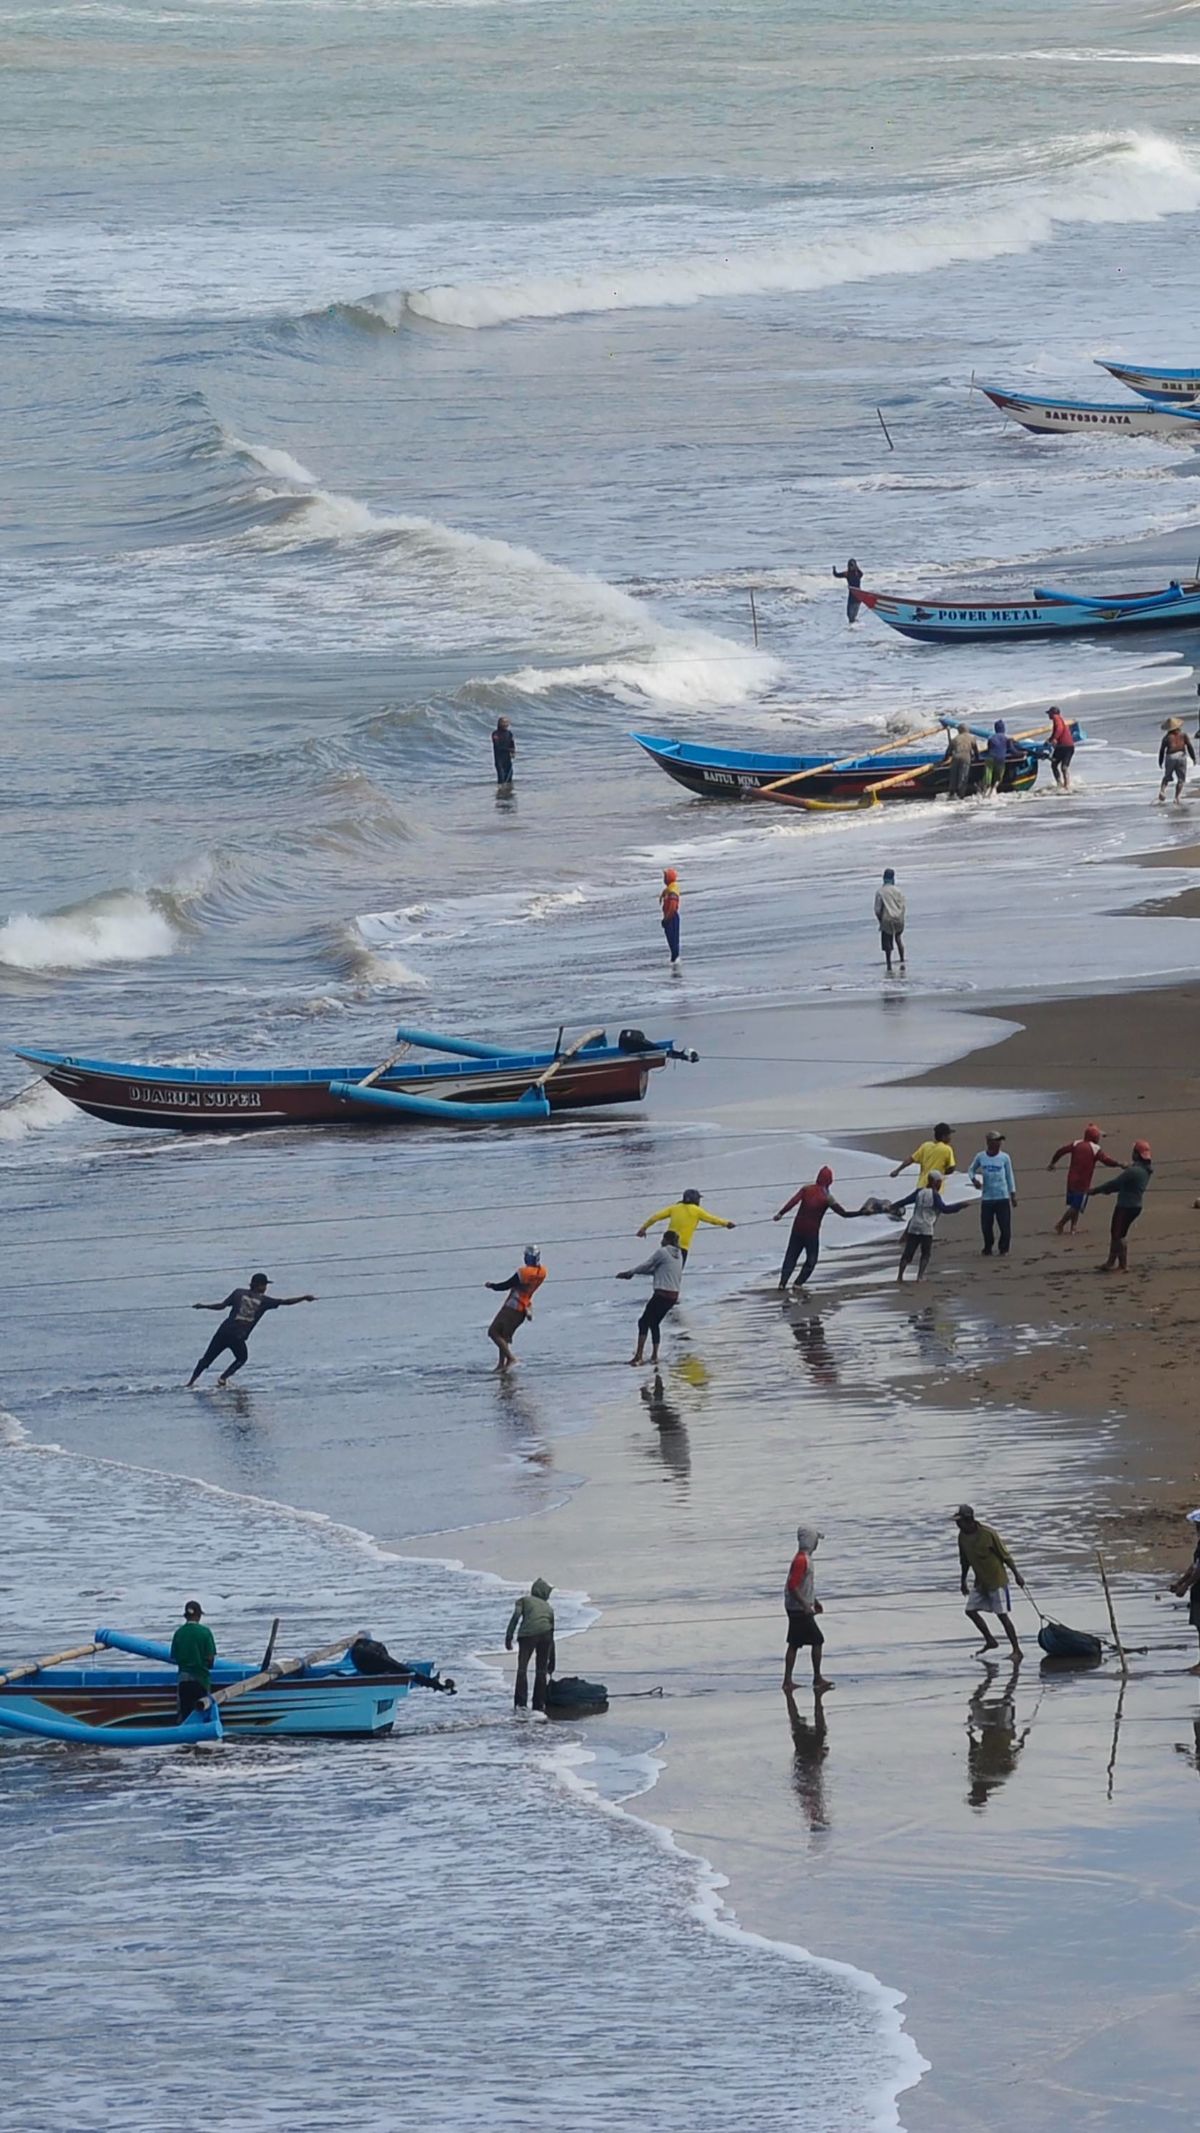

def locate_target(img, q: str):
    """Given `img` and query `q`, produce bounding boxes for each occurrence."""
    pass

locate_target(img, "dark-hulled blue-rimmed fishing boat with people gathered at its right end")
[629,719,1042,808]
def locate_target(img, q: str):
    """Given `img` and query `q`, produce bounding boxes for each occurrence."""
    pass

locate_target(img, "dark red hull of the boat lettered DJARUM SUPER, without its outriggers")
[9,1045,669,1133]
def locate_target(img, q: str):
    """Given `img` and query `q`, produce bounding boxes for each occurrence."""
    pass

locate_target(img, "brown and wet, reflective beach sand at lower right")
[450,972,1200,2133]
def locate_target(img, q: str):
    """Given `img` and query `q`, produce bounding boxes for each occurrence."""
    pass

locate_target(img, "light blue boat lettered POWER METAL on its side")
[859,578,1200,644]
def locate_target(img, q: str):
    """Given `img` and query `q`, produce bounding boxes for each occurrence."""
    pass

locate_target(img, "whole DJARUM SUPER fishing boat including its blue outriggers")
[17,1028,695,1133]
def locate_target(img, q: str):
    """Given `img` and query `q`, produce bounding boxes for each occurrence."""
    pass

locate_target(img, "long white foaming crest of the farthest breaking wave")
[356,132,1200,331]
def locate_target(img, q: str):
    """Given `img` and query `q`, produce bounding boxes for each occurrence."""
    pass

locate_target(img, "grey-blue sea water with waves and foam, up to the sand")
[0,0,1200,2133]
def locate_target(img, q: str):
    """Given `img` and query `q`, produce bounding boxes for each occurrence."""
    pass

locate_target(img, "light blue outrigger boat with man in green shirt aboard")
[0,1630,445,1747]
